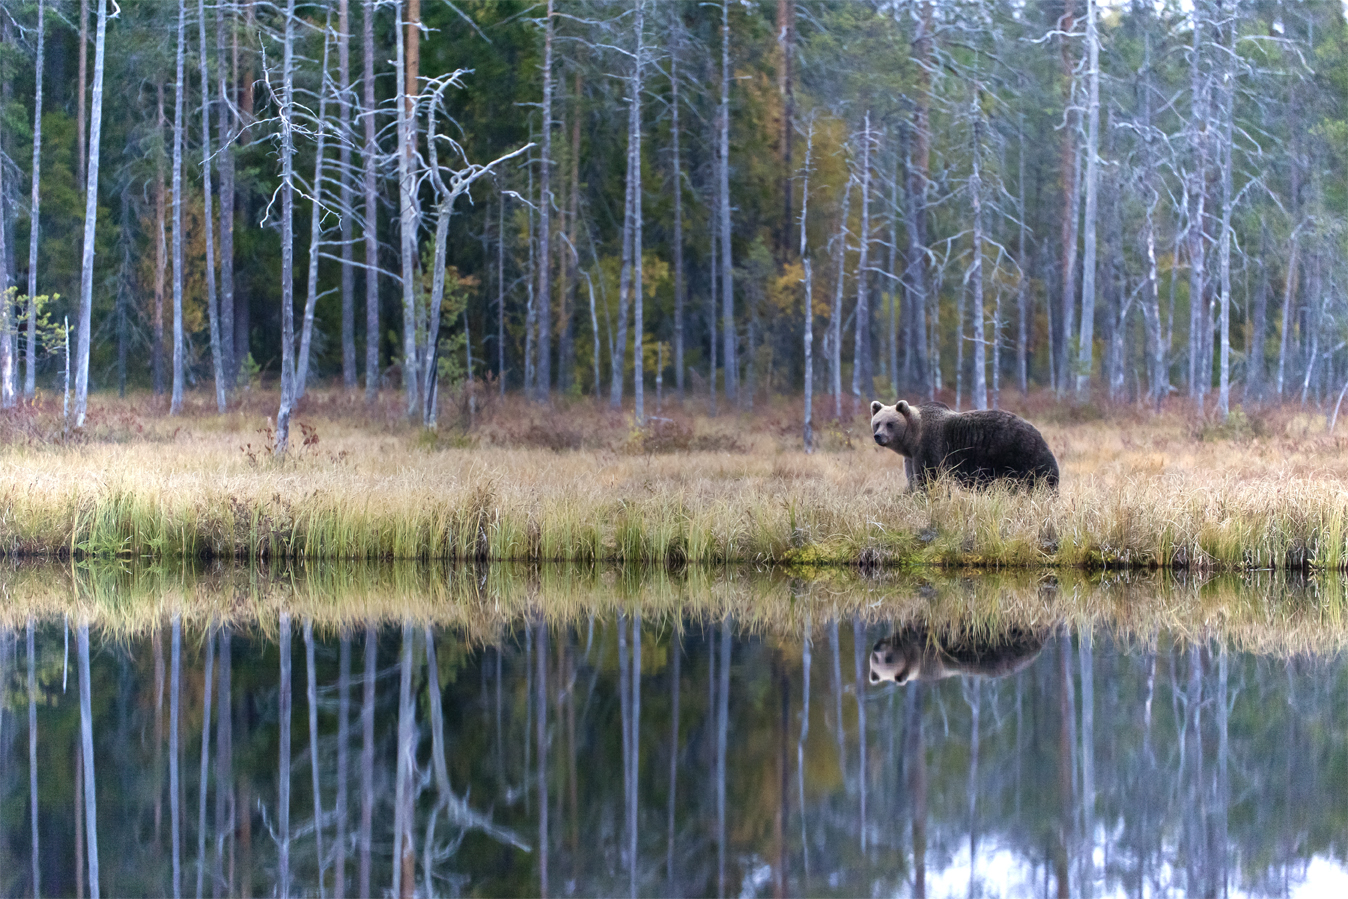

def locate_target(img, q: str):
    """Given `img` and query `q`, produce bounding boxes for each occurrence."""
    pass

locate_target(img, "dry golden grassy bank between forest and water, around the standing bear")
[0,394,1348,571]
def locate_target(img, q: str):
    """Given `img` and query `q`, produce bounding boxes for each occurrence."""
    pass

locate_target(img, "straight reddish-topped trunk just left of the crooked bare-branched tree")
[395,0,421,418]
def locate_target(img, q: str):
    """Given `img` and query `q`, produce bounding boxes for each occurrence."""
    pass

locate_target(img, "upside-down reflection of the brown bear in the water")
[871,627,1043,683]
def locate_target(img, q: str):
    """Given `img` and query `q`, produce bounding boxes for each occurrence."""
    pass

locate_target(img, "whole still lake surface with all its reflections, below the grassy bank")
[0,570,1348,896]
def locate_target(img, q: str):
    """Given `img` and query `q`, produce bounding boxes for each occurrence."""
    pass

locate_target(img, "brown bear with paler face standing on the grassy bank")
[871,399,1058,491]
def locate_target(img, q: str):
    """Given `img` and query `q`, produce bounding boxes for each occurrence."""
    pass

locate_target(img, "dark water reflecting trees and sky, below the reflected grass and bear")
[0,609,1348,896]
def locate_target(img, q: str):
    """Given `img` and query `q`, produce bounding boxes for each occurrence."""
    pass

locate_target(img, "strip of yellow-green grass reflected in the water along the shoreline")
[0,562,1348,655]
